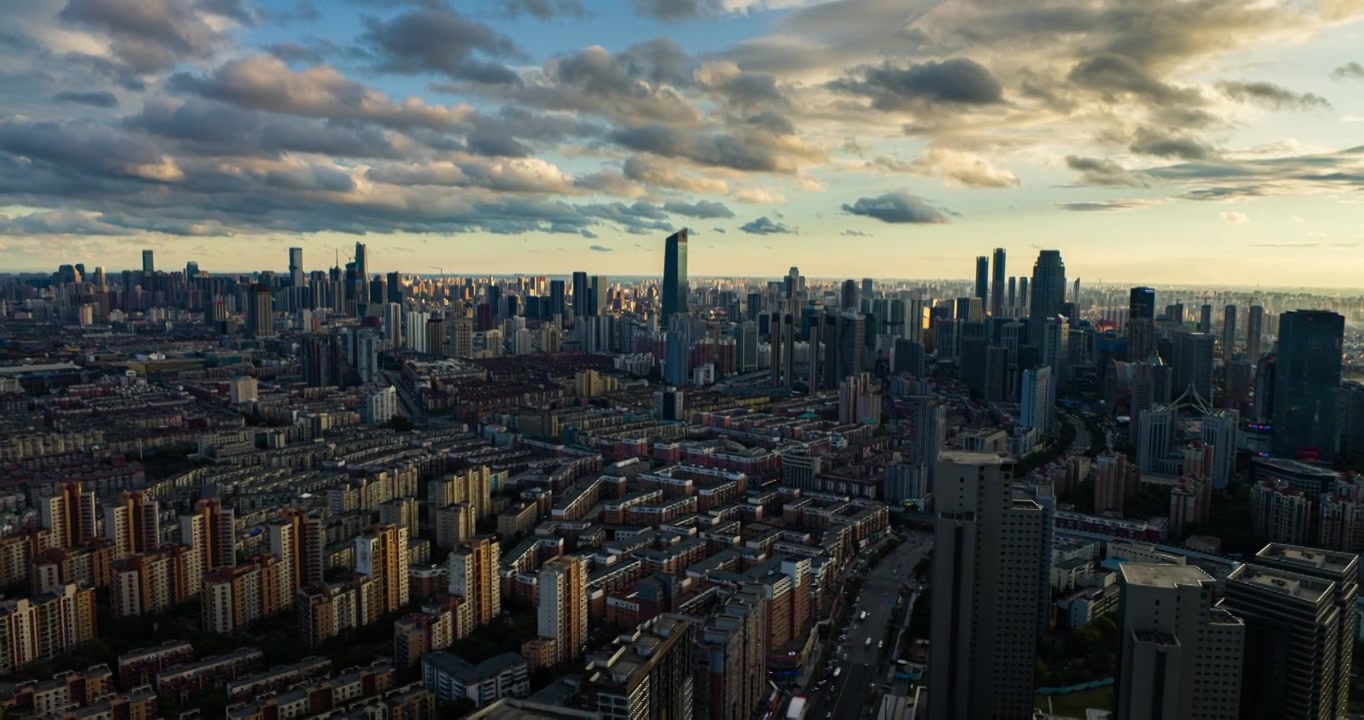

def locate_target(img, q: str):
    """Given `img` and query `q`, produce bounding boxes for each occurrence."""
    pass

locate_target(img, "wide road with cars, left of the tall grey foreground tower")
[806,530,933,720]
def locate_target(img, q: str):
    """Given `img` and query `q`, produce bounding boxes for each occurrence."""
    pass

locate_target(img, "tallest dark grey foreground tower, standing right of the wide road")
[929,453,1049,720]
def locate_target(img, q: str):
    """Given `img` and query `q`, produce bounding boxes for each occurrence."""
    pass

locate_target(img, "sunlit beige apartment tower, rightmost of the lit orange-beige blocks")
[527,555,588,665]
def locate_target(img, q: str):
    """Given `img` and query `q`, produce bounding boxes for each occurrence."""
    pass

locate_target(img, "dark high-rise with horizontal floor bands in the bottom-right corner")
[1224,543,1359,720]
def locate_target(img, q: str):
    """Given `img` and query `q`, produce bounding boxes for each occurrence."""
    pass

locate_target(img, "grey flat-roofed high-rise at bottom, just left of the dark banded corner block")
[1116,563,1245,720]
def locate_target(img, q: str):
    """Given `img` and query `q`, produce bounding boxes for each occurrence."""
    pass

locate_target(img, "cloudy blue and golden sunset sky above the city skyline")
[0,0,1364,288]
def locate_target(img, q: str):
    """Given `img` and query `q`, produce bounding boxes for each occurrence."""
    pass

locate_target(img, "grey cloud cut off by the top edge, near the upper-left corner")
[59,0,237,72]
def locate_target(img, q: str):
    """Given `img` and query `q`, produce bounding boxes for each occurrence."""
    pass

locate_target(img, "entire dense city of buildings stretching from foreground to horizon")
[0,230,1364,720]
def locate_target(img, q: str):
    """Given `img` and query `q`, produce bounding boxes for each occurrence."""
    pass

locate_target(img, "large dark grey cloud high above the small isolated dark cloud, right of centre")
[829,57,1004,110]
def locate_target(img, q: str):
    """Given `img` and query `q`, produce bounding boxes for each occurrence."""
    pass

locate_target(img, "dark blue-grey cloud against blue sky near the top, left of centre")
[360,8,524,85]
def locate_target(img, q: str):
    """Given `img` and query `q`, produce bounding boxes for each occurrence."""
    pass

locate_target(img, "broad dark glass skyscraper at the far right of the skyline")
[1271,310,1345,461]
